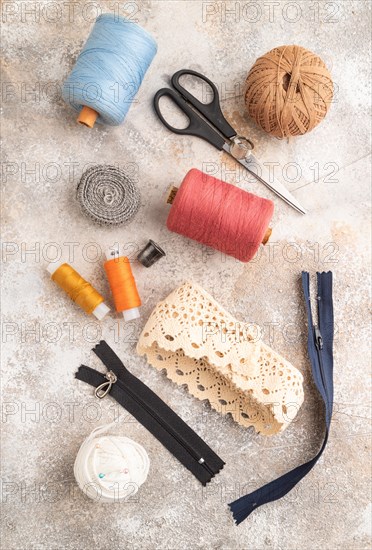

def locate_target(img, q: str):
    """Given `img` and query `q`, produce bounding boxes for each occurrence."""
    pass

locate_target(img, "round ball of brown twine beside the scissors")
[245,46,333,137]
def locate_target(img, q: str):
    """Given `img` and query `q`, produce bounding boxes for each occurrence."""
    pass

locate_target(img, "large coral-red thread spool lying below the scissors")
[167,168,274,262]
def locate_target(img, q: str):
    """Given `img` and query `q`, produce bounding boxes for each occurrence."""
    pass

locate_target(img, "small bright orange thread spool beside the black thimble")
[104,249,141,321]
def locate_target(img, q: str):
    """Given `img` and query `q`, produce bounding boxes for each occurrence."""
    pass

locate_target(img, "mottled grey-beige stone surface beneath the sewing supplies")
[2,0,371,550]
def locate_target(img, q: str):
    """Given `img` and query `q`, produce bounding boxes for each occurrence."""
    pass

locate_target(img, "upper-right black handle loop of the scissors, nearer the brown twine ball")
[171,69,236,139]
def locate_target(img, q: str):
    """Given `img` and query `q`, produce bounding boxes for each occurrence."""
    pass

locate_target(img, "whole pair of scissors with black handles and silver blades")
[154,69,306,214]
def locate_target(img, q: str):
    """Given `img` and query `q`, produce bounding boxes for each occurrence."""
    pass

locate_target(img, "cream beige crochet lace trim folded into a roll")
[137,283,304,435]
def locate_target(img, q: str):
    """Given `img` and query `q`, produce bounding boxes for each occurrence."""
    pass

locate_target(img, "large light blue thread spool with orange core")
[62,13,157,128]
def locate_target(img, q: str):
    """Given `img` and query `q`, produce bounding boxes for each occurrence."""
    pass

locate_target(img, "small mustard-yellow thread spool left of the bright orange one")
[47,262,110,321]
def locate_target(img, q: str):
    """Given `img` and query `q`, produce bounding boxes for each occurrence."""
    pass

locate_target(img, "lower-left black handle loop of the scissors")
[154,88,225,150]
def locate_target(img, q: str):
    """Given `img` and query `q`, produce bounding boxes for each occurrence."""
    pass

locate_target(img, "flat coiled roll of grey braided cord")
[76,164,141,225]
